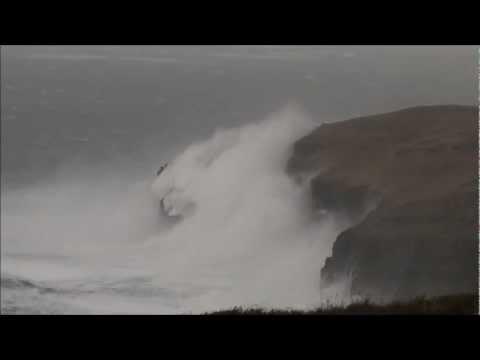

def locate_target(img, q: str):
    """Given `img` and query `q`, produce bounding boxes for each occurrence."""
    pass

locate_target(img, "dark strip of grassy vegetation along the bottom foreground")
[207,294,478,315]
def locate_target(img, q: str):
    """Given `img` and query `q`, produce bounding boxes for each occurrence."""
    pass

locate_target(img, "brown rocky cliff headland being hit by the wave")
[287,106,478,298]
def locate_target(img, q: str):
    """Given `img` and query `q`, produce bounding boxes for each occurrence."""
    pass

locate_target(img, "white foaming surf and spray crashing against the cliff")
[1,105,345,313]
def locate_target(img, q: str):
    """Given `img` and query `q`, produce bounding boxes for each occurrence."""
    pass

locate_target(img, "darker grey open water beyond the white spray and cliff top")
[1,46,478,188]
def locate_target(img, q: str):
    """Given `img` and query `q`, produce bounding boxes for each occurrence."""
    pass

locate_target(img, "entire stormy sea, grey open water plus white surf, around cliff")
[1,46,477,314]
